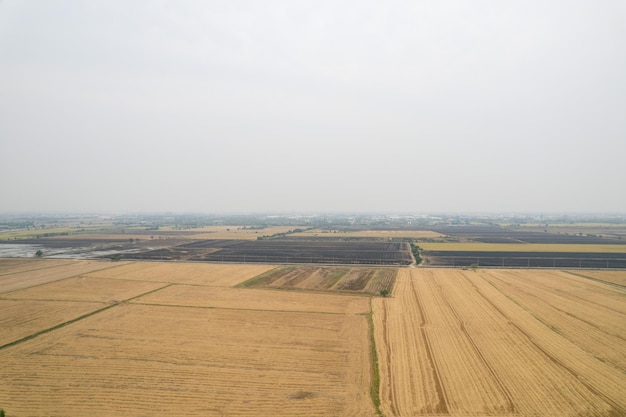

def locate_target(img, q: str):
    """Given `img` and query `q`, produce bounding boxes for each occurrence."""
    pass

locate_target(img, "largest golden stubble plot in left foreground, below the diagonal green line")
[0,304,374,416]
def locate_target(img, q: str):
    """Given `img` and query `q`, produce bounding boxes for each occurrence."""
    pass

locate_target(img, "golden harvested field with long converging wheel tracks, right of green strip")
[374,269,626,416]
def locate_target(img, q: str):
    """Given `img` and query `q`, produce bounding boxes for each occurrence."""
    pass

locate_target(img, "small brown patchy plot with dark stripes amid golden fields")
[241,266,397,295]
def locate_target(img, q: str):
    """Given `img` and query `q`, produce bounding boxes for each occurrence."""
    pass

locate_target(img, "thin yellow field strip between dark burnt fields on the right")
[419,242,626,253]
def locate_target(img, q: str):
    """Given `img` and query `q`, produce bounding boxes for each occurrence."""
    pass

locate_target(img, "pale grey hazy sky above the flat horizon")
[0,0,626,213]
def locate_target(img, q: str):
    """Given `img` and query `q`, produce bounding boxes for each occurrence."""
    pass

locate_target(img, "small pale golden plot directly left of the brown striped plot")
[83,262,276,287]
